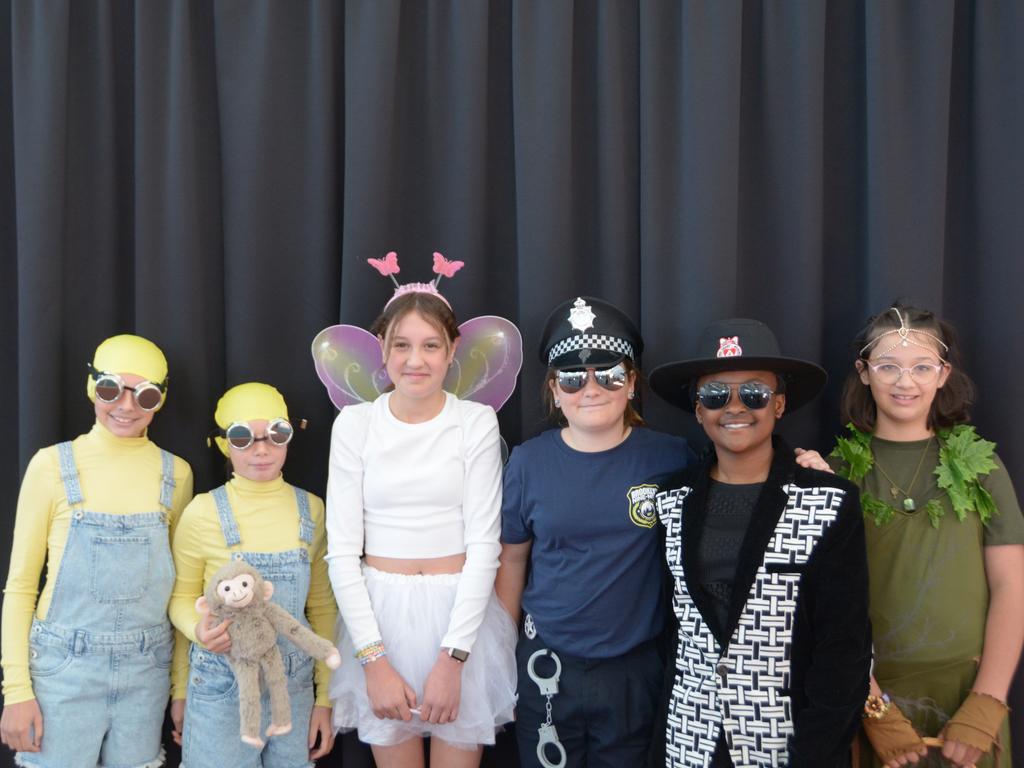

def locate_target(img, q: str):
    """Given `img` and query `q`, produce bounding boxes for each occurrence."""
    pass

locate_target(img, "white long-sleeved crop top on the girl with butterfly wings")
[327,393,502,650]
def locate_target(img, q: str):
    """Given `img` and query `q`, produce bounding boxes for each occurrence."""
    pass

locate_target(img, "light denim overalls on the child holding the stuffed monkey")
[181,485,313,768]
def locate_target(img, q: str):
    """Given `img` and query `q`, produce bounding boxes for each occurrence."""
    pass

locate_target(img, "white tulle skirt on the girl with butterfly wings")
[331,565,518,749]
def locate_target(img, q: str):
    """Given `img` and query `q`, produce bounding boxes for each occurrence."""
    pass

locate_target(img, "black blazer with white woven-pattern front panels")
[651,438,870,768]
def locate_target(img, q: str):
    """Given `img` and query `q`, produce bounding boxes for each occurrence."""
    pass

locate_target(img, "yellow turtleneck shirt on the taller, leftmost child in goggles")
[0,423,193,703]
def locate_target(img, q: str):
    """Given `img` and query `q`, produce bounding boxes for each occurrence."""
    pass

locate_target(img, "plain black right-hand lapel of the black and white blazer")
[725,437,796,643]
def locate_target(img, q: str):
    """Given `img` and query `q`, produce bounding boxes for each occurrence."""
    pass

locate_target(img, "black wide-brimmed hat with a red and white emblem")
[648,318,828,413]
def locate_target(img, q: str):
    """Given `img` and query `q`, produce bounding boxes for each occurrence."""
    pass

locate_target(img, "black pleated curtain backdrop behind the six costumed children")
[0,0,1024,766]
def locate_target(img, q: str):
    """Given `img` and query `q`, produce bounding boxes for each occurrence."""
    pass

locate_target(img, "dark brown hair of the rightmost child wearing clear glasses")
[840,301,974,432]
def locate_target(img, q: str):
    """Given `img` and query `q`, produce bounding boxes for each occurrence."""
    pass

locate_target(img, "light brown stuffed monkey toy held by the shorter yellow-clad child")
[196,560,341,748]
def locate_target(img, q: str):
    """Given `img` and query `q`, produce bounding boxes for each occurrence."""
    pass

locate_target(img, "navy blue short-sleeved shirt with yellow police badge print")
[502,427,693,658]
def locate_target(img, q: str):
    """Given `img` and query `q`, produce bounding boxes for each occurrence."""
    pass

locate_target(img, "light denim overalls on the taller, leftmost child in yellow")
[17,442,174,768]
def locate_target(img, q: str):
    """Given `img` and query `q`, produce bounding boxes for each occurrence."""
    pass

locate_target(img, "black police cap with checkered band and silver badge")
[540,296,643,371]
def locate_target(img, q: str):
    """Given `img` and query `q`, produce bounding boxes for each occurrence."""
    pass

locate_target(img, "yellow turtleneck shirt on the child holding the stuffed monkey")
[169,475,338,707]
